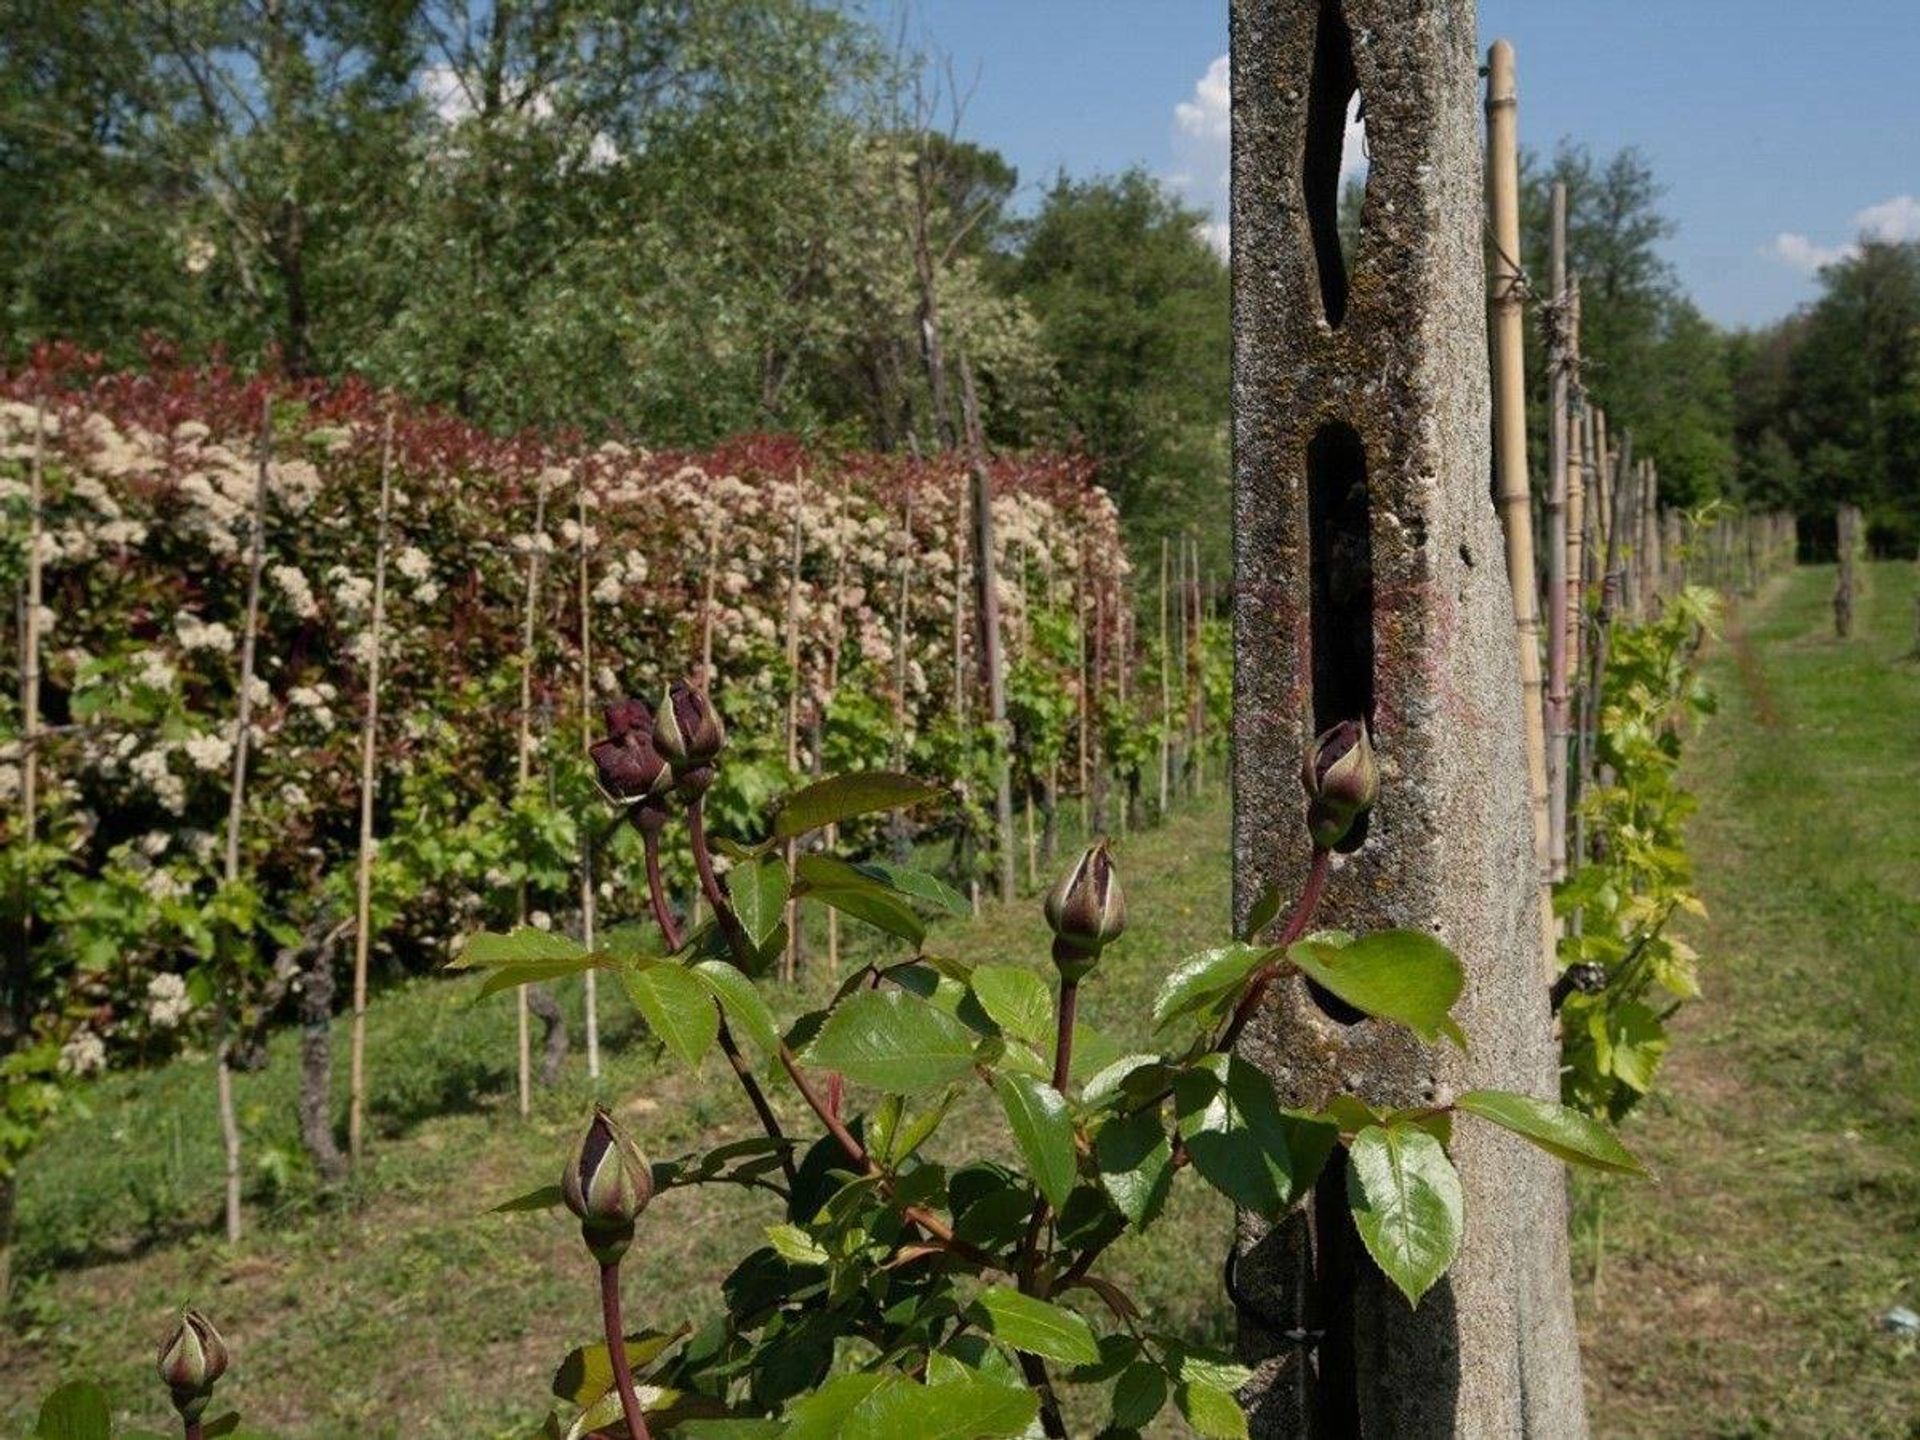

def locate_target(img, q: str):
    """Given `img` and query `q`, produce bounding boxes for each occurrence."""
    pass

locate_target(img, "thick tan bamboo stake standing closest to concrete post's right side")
[1486,40,1551,902]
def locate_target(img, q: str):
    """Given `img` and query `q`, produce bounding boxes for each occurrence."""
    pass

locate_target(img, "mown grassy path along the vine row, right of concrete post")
[1574,564,1920,1440]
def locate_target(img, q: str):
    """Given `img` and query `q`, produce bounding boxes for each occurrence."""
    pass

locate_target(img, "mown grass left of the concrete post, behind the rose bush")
[0,797,1231,1440]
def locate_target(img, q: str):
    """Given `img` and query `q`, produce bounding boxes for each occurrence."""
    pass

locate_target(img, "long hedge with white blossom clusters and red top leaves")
[0,355,1139,1090]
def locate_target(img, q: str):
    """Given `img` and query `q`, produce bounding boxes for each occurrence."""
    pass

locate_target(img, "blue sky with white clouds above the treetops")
[847,0,1920,324]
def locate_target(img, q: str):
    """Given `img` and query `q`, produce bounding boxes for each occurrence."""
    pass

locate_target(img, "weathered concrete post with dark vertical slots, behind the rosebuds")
[1233,0,1586,1440]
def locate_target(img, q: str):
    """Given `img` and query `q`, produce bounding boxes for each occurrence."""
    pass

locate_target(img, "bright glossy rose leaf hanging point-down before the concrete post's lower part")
[1346,1123,1463,1306]
